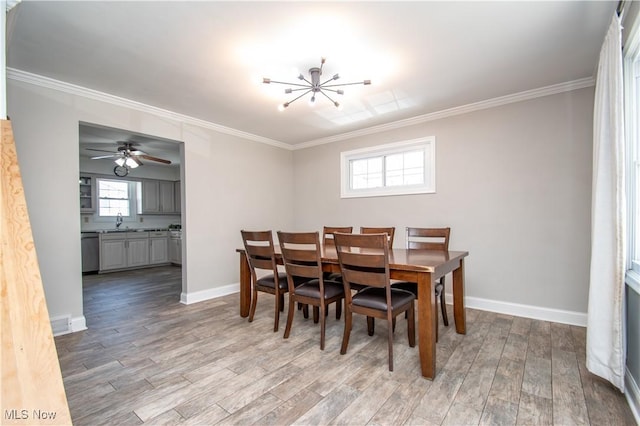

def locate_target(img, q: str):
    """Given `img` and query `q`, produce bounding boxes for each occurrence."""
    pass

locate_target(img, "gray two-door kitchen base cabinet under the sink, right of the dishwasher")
[100,232,149,271]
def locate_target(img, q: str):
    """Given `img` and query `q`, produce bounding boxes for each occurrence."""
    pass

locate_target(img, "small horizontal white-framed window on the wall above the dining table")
[340,137,436,198]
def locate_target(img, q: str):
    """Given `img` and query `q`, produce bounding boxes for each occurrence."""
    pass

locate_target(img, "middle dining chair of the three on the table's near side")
[278,231,344,350]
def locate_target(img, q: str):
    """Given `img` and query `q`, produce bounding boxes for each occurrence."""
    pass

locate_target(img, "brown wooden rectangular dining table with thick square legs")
[236,244,469,380]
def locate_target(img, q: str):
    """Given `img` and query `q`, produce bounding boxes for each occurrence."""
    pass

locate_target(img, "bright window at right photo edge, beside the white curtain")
[624,21,640,292]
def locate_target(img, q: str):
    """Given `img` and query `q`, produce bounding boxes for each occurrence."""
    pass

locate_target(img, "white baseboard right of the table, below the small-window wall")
[445,293,587,327]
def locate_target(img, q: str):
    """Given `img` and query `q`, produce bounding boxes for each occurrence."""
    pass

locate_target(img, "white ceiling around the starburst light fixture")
[7,0,618,160]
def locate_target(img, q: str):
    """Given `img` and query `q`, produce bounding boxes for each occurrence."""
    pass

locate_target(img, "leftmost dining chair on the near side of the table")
[240,230,289,332]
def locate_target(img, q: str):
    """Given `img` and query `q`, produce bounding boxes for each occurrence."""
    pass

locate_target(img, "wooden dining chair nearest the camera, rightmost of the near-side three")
[334,232,416,371]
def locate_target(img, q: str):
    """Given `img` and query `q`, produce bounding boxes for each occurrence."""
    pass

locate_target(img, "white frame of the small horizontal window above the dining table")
[340,136,436,198]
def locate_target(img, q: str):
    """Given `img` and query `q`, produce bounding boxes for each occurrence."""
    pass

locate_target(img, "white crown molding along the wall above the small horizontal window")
[293,77,595,150]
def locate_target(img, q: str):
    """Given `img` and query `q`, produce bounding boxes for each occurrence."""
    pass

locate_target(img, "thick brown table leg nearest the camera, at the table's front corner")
[418,272,438,380]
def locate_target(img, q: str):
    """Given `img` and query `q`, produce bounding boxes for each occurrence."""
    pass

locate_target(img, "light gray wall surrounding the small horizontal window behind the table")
[294,88,593,316]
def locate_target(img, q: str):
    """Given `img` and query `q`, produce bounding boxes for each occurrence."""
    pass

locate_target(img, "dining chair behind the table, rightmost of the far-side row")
[393,228,451,341]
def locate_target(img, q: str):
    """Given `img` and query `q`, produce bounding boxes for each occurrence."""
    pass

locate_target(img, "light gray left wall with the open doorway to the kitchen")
[7,76,293,320]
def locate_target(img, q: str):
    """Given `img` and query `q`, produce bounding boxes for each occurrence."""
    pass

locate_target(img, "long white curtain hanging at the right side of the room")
[587,14,626,392]
